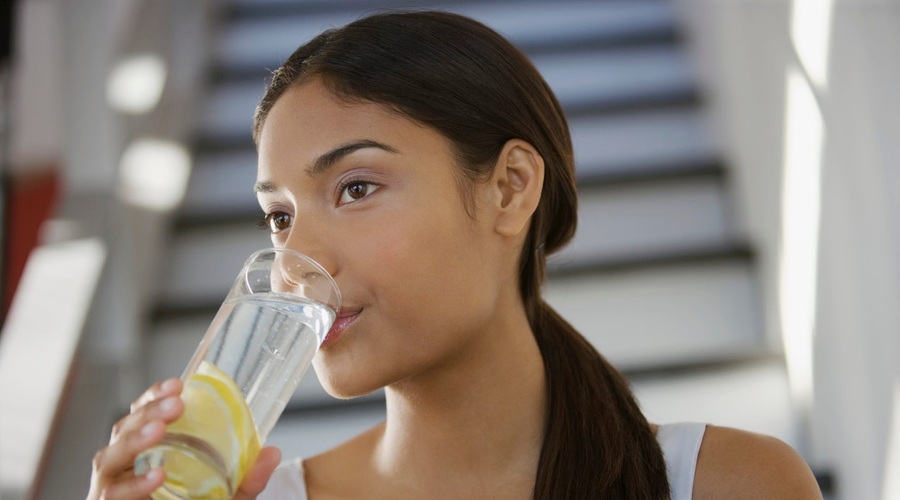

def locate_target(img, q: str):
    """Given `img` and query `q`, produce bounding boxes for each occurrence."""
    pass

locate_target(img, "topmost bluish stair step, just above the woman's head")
[213,0,676,73]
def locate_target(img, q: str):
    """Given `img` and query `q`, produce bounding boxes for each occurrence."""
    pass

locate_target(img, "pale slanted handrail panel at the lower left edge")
[0,238,107,500]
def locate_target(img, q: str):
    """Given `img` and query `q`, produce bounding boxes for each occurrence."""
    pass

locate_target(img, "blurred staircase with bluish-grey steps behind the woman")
[146,0,799,457]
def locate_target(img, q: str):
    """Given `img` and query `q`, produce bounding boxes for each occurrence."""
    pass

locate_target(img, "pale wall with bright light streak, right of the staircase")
[679,0,900,500]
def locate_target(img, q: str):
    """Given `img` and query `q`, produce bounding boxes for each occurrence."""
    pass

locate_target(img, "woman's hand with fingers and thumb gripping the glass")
[87,379,281,500]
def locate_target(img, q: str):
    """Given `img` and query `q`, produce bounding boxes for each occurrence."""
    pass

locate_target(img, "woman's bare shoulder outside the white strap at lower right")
[694,426,822,500]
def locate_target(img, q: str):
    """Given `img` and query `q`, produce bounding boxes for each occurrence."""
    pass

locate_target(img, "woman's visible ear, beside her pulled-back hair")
[490,139,544,236]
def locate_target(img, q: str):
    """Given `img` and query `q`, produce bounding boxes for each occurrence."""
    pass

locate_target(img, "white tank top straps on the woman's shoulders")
[257,423,706,500]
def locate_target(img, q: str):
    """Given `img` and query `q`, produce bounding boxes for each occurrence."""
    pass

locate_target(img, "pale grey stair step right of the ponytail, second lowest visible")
[544,259,769,371]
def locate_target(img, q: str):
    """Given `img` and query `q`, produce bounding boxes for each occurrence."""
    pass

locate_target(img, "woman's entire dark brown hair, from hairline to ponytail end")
[253,11,669,500]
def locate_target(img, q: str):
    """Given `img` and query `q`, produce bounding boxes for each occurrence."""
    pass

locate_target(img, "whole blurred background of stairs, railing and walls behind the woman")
[0,0,900,500]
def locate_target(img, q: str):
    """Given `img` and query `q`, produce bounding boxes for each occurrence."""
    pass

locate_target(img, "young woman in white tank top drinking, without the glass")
[90,12,820,500]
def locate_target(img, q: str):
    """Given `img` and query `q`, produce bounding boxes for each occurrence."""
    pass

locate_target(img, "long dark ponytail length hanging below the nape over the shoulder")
[531,301,669,500]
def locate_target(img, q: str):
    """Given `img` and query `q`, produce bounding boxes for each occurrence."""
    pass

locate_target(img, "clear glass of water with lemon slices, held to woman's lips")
[135,248,341,500]
